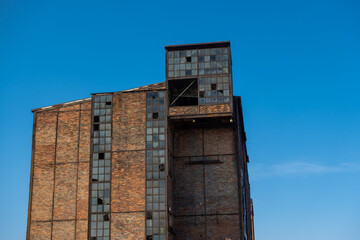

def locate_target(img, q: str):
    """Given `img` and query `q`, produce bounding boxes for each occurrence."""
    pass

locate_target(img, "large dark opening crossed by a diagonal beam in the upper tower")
[169,78,198,106]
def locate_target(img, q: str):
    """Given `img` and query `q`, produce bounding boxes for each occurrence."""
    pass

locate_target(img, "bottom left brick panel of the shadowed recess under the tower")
[174,216,206,240]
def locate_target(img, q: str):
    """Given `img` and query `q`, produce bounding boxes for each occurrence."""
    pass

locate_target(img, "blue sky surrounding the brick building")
[0,0,360,240]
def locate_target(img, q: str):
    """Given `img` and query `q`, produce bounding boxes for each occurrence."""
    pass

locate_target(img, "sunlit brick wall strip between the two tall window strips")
[111,92,146,240]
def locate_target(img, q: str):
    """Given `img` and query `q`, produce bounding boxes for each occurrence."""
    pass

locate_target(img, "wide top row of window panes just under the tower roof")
[167,48,229,78]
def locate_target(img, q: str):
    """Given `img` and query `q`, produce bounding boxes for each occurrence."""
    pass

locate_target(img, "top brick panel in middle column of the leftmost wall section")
[56,111,79,163]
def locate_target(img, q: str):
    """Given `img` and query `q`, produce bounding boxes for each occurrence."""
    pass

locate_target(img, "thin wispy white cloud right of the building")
[250,161,360,180]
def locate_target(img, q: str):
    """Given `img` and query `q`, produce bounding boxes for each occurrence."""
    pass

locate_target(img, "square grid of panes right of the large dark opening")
[199,76,230,105]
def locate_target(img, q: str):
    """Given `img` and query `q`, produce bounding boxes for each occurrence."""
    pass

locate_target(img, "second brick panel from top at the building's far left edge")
[31,164,54,221]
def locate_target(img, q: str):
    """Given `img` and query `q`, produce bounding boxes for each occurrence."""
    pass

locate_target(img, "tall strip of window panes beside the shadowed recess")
[146,92,167,240]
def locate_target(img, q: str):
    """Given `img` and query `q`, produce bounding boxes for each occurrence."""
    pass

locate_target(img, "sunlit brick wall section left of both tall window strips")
[27,102,91,240]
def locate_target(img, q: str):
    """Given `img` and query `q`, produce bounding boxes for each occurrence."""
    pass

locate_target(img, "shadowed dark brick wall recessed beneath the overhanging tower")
[174,127,240,240]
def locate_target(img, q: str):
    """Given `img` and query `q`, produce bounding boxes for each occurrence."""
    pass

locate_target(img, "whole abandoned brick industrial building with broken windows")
[27,41,254,240]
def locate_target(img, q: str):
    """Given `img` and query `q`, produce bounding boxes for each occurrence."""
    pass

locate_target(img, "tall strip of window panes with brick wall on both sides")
[90,95,112,240]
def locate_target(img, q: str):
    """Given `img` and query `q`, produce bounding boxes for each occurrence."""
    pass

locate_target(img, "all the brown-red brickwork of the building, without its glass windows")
[27,41,254,240]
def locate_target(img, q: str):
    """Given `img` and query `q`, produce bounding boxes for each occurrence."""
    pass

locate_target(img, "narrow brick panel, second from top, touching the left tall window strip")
[77,163,89,219]
